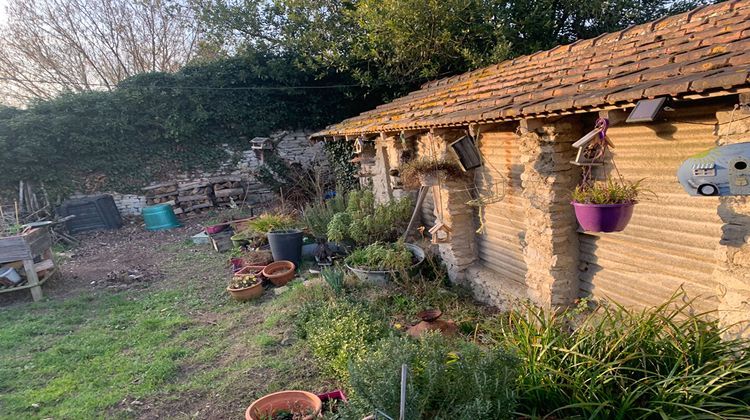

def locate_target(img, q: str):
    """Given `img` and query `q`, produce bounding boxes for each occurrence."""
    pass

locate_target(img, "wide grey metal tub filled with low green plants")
[344,242,425,283]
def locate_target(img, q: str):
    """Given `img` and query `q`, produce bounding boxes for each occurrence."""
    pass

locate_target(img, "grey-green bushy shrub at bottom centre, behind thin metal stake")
[350,334,517,420]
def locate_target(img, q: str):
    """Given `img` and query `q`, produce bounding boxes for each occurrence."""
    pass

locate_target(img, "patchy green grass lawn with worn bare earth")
[0,244,326,419]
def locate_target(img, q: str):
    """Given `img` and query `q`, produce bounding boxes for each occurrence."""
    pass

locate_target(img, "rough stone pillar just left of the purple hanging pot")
[520,117,582,307]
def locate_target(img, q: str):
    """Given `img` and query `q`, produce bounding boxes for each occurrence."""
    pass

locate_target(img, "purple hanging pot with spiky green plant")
[571,178,641,232]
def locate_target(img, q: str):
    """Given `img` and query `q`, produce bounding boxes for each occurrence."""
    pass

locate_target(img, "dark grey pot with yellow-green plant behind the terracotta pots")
[250,214,302,266]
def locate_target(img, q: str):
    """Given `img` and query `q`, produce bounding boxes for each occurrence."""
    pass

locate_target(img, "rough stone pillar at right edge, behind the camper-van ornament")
[714,106,750,338]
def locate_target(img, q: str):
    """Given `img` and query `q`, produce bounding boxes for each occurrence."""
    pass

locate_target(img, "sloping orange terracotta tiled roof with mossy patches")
[314,0,750,136]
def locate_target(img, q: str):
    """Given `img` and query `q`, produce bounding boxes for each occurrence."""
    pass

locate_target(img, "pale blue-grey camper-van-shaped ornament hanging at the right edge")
[677,142,750,196]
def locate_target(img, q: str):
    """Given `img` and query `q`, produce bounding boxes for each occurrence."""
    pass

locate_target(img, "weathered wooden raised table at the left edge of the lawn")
[0,227,57,301]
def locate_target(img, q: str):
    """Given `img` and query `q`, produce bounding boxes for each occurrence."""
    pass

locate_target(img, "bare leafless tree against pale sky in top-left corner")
[0,0,198,102]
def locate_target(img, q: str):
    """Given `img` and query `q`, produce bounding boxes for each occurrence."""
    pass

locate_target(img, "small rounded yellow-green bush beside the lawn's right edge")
[298,301,387,383]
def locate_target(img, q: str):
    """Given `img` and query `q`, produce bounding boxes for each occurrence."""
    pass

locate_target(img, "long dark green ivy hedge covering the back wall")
[0,52,369,197]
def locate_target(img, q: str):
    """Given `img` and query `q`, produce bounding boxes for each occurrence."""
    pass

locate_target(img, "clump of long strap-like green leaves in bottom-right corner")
[496,299,750,418]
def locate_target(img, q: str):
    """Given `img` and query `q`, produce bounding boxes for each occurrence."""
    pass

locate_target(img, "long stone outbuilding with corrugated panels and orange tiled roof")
[312,0,750,340]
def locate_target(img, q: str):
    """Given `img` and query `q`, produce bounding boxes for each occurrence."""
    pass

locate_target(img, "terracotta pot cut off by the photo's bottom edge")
[245,391,323,420]
